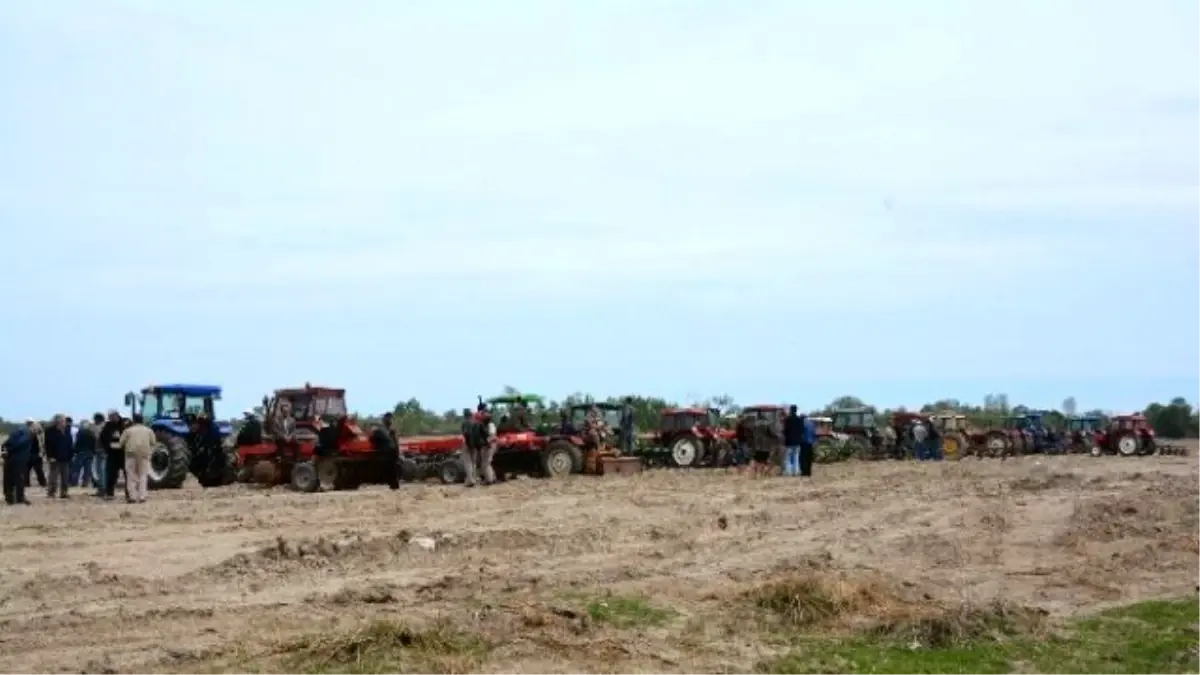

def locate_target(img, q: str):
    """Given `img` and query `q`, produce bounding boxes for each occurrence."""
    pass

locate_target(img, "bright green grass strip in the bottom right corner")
[758,599,1200,675]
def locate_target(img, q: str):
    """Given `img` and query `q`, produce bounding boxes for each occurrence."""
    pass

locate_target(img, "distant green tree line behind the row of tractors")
[0,387,1200,438]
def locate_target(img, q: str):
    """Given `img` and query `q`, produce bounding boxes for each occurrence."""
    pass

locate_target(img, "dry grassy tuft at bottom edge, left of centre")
[282,621,491,675]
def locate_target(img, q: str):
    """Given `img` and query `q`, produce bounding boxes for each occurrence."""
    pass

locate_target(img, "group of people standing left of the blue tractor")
[0,411,156,506]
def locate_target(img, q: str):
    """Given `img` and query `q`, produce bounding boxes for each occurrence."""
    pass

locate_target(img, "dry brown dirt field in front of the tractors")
[0,446,1200,674]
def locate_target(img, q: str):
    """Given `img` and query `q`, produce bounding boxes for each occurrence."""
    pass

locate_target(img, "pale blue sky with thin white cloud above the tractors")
[0,0,1200,418]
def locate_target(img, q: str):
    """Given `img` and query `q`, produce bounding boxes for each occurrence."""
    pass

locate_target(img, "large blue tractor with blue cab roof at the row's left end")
[125,384,238,490]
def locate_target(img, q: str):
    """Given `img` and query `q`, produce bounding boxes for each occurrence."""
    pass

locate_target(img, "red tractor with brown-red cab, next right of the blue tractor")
[238,384,400,492]
